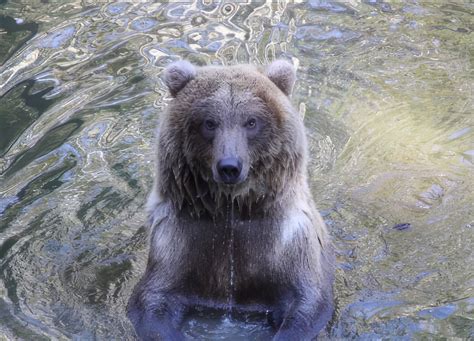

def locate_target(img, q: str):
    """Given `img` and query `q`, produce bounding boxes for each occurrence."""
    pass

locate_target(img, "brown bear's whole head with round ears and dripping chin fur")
[158,61,305,216]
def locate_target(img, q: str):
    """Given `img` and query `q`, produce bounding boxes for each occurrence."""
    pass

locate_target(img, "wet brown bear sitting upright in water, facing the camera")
[127,60,334,340]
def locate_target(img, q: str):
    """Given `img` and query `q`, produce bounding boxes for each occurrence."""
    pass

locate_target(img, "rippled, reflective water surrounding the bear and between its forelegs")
[0,0,474,340]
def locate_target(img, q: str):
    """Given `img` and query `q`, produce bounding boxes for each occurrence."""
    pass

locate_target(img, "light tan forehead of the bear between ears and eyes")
[176,65,292,121]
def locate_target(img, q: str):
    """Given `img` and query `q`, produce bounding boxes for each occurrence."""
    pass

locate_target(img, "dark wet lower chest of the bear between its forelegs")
[183,224,284,307]
